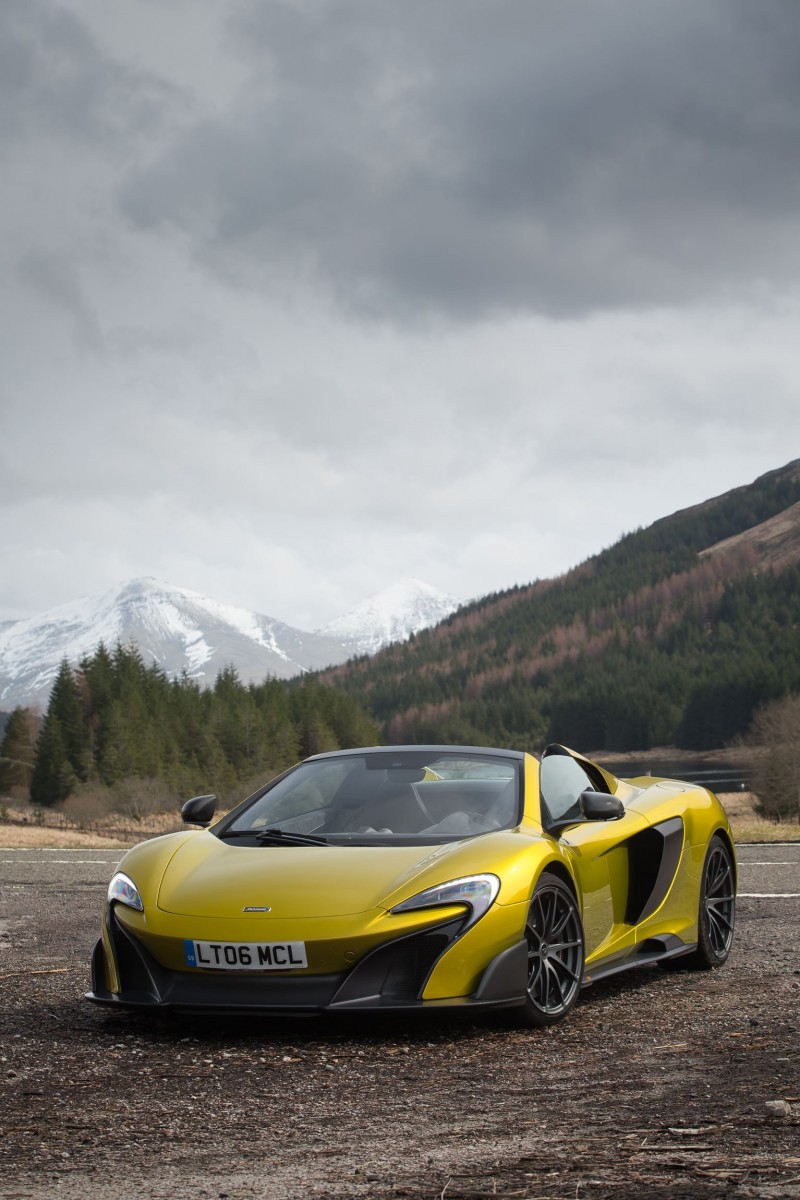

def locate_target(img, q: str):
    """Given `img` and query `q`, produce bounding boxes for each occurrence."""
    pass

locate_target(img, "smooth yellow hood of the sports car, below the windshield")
[157,833,482,919]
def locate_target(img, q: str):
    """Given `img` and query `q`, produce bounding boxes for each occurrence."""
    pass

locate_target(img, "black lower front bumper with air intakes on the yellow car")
[86,908,528,1014]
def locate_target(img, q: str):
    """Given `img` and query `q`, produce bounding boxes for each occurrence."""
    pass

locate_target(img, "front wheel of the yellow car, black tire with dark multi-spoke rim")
[515,871,584,1027]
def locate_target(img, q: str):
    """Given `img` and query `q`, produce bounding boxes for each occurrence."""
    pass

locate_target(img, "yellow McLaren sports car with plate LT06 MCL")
[88,745,736,1026]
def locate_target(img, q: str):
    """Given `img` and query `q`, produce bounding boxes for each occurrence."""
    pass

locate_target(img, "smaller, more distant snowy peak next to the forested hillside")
[317,578,459,654]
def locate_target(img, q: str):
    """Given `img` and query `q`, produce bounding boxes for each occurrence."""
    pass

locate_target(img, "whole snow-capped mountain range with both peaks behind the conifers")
[0,578,456,710]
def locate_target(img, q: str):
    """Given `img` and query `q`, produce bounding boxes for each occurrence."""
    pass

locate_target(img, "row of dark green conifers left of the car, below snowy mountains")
[0,644,380,805]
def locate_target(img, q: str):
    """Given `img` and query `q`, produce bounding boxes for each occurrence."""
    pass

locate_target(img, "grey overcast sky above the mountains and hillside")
[0,0,800,629]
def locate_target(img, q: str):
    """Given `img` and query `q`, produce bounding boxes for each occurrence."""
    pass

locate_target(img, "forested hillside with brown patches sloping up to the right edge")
[323,460,800,750]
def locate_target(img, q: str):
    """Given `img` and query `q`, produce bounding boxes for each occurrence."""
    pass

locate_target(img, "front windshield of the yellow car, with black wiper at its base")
[220,750,521,845]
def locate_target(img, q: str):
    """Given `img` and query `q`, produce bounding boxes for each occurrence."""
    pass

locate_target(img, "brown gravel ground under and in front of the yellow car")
[0,871,800,1200]
